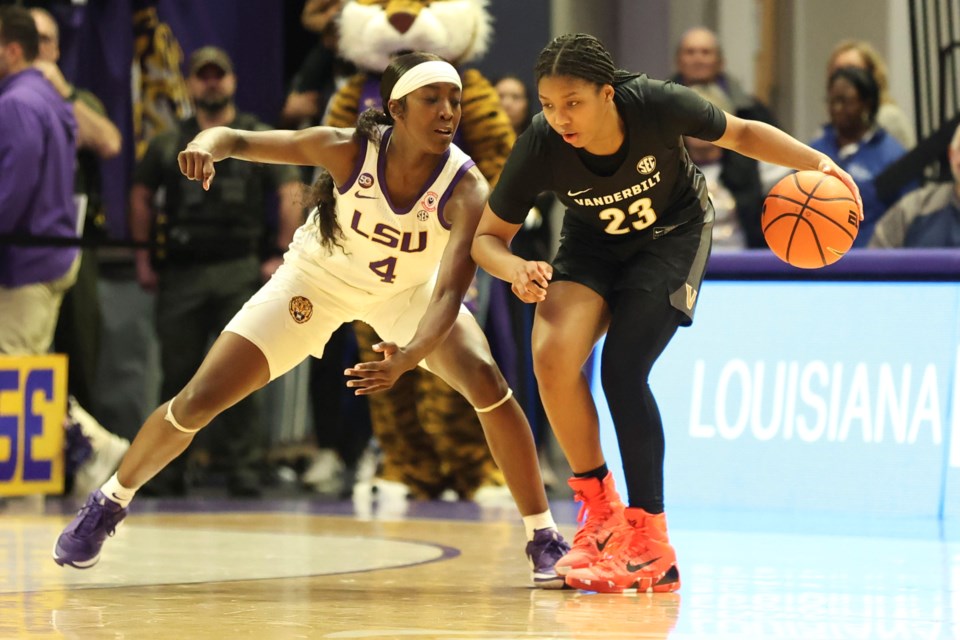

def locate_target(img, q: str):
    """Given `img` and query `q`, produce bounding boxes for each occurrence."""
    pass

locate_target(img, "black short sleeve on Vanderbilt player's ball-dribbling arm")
[651,81,727,144]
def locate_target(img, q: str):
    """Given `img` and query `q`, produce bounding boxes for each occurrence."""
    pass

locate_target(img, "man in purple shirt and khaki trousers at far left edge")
[0,6,78,355]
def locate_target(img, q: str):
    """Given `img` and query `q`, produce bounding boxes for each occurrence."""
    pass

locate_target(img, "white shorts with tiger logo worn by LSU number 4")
[223,263,470,380]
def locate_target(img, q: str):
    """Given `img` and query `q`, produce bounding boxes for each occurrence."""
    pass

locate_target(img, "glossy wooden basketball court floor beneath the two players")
[0,498,960,640]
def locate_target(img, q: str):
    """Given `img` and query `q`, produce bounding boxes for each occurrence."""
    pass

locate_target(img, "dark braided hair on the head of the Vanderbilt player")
[534,33,639,86]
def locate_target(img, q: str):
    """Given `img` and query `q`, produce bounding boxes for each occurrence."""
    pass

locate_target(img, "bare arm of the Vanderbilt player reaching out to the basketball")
[715,113,863,218]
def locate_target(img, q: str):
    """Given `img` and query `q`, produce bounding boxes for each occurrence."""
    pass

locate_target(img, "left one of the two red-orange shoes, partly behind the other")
[555,472,624,576]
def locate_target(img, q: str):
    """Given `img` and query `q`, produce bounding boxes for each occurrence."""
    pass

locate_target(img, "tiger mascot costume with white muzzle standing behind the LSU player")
[324,0,515,500]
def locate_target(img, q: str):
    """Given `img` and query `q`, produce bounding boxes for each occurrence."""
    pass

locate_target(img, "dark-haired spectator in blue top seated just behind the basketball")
[810,67,915,247]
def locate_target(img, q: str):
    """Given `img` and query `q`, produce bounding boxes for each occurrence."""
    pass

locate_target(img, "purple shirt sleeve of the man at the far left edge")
[0,105,44,233]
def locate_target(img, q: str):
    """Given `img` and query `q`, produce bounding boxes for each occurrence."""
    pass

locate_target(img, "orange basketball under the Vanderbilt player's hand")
[760,171,860,269]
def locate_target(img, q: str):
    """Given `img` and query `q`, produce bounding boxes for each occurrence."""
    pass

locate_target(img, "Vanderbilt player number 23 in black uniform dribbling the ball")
[473,34,862,592]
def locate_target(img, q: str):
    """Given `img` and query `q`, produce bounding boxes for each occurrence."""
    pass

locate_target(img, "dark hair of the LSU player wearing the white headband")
[312,52,443,253]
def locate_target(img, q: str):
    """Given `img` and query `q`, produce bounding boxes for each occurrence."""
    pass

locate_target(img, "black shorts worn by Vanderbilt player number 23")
[553,209,713,326]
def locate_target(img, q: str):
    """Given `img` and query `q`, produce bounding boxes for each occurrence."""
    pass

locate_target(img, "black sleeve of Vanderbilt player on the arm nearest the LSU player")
[490,125,550,224]
